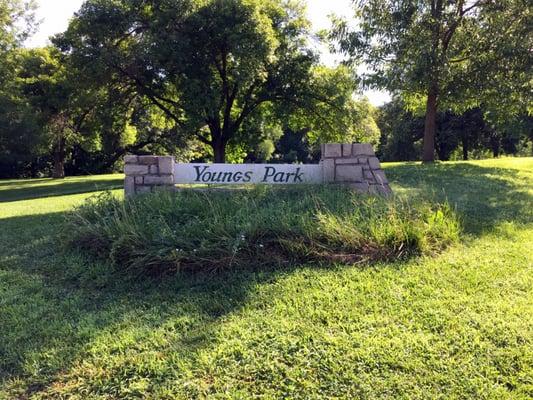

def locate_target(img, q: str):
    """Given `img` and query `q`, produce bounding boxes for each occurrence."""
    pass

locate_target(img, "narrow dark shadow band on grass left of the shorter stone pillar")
[0,178,124,203]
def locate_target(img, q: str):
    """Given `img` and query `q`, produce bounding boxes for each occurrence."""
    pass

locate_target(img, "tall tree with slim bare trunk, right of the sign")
[333,0,533,161]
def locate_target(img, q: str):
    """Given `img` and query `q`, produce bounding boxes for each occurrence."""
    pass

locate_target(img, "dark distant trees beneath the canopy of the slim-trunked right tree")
[376,98,533,161]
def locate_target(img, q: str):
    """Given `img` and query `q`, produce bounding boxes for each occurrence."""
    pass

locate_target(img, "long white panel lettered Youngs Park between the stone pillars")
[174,164,323,185]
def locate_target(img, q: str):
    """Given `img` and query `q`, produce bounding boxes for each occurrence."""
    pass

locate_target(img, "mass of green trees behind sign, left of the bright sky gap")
[0,0,379,177]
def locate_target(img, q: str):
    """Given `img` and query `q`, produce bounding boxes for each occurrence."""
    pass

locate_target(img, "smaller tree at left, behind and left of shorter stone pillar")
[12,47,140,178]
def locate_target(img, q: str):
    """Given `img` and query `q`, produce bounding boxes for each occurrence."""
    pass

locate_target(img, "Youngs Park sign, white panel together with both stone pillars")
[124,143,391,196]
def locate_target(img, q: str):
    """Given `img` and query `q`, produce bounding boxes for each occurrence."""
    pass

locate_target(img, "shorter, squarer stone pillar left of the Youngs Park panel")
[124,155,175,196]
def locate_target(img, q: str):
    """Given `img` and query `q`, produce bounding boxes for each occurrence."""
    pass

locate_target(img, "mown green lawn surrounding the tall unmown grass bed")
[0,158,533,399]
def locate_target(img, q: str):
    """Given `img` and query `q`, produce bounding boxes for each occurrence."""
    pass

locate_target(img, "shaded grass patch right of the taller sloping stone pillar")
[386,163,533,235]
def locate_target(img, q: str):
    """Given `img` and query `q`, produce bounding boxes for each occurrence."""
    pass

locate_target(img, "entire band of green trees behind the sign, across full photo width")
[0,0,533,178]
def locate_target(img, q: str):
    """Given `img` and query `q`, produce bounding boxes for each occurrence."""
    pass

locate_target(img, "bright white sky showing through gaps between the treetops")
[26,0,390,106]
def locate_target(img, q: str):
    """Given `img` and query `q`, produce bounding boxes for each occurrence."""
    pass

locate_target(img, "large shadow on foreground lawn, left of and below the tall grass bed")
[0,213,288,398]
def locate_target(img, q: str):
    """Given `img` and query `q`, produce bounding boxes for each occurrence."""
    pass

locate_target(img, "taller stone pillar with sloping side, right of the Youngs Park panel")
[320,143,392,196]
